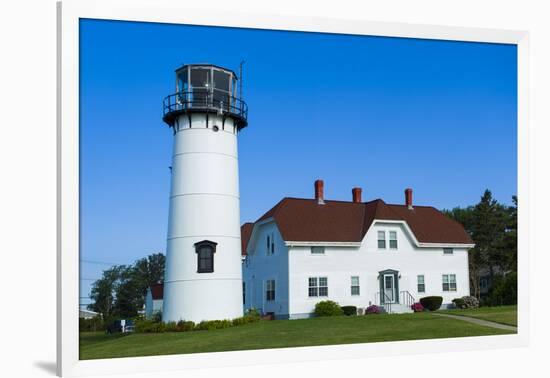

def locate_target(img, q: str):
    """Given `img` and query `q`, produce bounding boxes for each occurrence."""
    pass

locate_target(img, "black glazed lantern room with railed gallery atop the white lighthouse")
[163,64,248,130]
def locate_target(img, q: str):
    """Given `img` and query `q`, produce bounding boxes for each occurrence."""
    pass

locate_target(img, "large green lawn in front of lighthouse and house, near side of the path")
[80,313,513,360]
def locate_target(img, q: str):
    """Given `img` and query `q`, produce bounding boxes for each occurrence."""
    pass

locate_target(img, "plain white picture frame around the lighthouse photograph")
[57,0,529,376]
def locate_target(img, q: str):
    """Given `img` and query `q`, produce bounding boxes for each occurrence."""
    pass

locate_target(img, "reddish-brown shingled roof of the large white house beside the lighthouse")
[241,198,473,248]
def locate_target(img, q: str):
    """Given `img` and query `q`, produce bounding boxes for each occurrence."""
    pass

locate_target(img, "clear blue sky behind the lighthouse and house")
[80,20,517,303]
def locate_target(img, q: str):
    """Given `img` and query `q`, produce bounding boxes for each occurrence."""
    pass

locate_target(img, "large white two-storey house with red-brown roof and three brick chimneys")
[241,180,474,319]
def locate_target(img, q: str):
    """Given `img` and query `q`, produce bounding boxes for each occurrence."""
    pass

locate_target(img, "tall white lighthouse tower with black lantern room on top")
[162,64,248,322]
